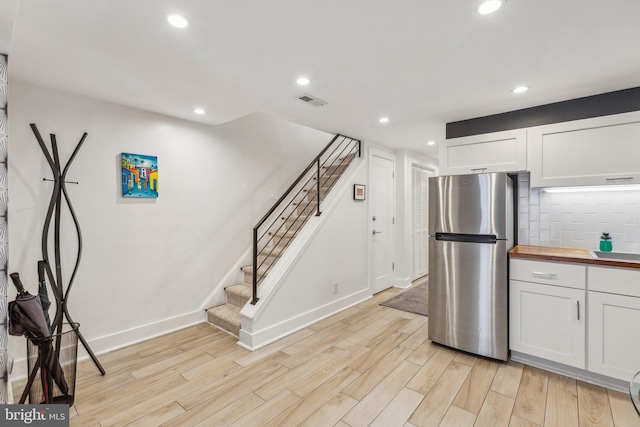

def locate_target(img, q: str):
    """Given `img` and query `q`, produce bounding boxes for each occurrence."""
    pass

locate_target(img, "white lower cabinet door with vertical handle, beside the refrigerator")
[509,280,585,369]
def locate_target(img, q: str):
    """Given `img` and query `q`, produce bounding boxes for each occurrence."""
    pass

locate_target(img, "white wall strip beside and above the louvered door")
[394,150,438,287]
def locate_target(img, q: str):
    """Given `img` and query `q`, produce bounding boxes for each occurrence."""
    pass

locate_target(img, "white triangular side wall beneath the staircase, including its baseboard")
[238,157,371,350]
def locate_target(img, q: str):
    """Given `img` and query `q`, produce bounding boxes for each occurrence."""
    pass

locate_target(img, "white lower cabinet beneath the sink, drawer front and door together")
[588,266,640,381]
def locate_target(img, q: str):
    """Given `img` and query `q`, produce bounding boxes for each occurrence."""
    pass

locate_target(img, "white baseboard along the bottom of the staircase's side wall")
[238,289,371,351]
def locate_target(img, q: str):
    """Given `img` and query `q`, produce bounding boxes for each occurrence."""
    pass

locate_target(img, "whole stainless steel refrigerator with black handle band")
[429,173,514,360]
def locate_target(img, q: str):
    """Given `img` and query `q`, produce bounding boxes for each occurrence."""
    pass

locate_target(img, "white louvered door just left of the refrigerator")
[411,165,433,280]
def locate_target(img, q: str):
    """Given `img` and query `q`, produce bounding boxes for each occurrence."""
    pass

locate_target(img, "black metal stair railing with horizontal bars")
[251,134,362,304]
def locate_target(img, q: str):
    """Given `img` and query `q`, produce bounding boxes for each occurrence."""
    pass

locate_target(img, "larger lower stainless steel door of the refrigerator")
[429,237,509,360]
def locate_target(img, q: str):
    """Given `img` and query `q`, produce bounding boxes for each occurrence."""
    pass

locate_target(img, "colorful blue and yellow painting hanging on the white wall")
[120,153,158,198]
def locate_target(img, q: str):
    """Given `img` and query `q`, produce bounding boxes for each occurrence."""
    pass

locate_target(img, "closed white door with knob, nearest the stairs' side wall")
[369,154,394,293]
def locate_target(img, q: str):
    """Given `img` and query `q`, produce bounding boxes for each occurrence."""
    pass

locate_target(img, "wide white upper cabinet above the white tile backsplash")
[527,111,640,187]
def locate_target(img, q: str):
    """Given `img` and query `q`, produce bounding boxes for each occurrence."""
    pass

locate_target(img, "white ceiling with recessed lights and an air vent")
[0,0,640,157]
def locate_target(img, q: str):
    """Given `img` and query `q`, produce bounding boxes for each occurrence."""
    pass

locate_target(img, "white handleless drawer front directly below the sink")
[587,265,640,297]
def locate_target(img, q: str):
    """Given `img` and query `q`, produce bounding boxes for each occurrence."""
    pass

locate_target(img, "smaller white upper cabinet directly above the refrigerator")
[439,129,527,175]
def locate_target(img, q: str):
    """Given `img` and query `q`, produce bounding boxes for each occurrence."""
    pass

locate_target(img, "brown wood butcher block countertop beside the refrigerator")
[509,245,640,269]
